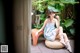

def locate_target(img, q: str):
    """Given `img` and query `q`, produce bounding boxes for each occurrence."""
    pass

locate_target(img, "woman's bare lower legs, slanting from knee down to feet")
[59,26,72,52]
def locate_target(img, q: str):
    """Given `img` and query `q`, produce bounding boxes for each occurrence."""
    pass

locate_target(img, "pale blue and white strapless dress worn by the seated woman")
[44,23,56,41]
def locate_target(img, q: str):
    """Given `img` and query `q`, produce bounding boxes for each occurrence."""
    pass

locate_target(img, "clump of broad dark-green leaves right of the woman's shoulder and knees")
[61,19,75,36]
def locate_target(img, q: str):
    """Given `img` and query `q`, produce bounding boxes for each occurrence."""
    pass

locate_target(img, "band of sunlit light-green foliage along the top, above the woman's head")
[32,0,79,12]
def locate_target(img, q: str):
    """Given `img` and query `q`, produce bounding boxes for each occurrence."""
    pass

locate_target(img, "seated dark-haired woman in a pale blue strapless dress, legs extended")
[36,6,72,52]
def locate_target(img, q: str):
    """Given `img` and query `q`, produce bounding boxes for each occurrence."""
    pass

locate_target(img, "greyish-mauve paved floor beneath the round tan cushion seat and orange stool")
[31,40,74,53]
